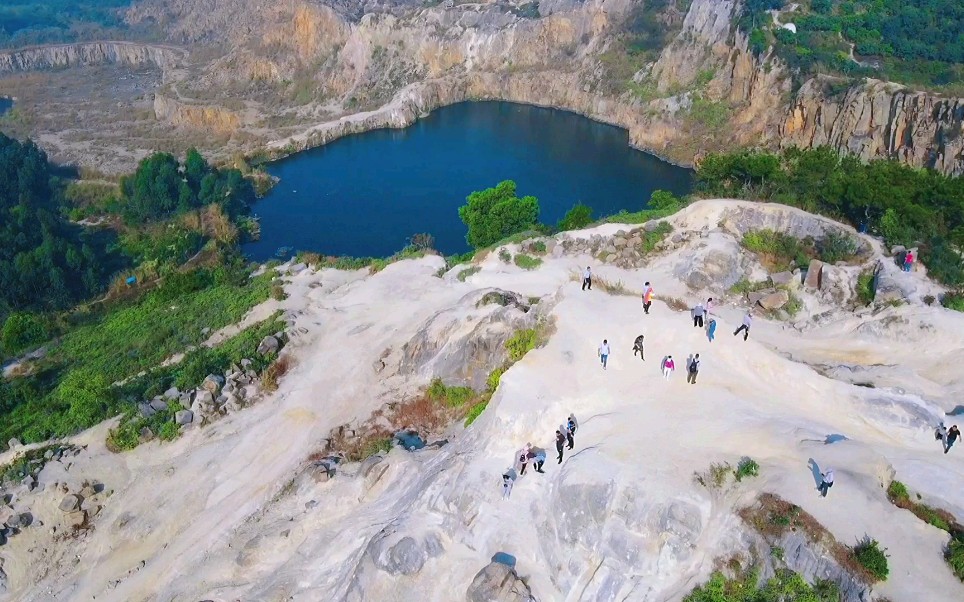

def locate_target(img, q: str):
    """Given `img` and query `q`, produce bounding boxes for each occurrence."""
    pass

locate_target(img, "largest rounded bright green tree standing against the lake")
[459,180,539,249]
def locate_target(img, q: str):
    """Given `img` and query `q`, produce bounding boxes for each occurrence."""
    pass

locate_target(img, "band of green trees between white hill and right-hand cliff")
[696,148,964,290]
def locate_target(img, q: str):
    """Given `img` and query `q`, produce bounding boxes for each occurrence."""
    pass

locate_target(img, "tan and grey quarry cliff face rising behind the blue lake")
[0,0,964,174]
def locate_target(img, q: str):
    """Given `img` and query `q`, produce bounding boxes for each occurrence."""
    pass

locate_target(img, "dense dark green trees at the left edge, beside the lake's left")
[0,134,116,322]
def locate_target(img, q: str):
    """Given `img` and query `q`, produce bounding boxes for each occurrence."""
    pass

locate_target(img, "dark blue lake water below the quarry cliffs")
[244,102,692,260]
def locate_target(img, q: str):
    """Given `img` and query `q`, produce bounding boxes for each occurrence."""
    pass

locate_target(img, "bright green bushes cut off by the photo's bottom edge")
[683,569,840,602]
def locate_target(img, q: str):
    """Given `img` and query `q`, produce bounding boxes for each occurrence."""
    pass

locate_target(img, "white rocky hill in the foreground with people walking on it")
[0,201,964,602]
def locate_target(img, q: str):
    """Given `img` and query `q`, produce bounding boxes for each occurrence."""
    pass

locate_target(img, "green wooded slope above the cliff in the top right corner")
[739,0,964,92]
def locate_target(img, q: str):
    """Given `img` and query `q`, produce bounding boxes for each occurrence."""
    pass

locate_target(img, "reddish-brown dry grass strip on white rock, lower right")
[738,493,877,584]
